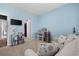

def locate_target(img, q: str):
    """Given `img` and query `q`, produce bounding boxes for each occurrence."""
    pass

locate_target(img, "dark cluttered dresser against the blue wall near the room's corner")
[35,29,50,42]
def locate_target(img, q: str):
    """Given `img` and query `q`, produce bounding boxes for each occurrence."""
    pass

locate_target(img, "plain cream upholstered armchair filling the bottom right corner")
[56,35,79,56]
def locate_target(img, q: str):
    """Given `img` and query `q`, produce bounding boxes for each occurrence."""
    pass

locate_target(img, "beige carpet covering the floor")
[0,40,45,56]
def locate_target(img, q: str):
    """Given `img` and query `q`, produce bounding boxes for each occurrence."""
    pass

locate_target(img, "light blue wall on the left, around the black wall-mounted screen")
[0,4,37,45]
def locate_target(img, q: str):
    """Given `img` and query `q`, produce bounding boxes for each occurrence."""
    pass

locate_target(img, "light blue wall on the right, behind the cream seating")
[39,4,78,39]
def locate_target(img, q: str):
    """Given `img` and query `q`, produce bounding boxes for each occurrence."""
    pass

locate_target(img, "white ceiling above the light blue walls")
[6,3,64,15]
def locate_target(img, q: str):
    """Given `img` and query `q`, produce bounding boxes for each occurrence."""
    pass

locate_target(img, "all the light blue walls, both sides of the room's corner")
[0,4,79,44]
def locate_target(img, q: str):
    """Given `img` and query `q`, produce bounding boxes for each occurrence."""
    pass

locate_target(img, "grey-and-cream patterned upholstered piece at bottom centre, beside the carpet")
[37,43,58,56]
